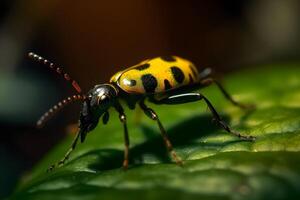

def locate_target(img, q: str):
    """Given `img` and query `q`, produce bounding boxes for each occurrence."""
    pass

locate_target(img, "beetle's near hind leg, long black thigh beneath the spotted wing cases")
[154,93,255,140]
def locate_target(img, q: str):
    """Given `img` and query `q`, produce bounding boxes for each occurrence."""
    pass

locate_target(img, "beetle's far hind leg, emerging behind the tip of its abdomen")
[200,78,255,109]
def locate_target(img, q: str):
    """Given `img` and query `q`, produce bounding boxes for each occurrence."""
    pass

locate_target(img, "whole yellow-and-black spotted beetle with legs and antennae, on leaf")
[28,52,255,170]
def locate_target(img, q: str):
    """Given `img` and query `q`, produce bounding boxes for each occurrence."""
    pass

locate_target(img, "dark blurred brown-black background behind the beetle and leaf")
[0,0,300,198]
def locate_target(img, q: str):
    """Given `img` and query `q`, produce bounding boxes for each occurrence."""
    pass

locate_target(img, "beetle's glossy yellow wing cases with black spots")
[111,56,199,94]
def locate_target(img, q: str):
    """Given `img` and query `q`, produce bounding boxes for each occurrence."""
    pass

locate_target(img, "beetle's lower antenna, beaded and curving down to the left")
[36,94,86,128]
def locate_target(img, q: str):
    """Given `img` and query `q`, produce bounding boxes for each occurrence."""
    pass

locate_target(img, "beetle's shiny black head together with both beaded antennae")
[28,52,118,142]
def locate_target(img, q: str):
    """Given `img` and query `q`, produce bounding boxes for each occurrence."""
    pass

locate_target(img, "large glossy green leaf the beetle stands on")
[12,64,300,200]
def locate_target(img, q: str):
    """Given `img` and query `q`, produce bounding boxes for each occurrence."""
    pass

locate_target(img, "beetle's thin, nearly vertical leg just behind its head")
[115,103,129,169]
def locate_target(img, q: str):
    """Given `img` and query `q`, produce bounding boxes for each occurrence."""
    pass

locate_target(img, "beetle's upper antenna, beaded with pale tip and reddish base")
[28,52,82,93]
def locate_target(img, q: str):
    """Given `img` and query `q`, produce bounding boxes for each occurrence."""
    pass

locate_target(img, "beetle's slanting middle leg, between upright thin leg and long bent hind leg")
[139,101,183,165]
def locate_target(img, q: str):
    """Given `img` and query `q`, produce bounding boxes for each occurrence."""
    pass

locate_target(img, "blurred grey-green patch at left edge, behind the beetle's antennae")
[0,71,57,126]
